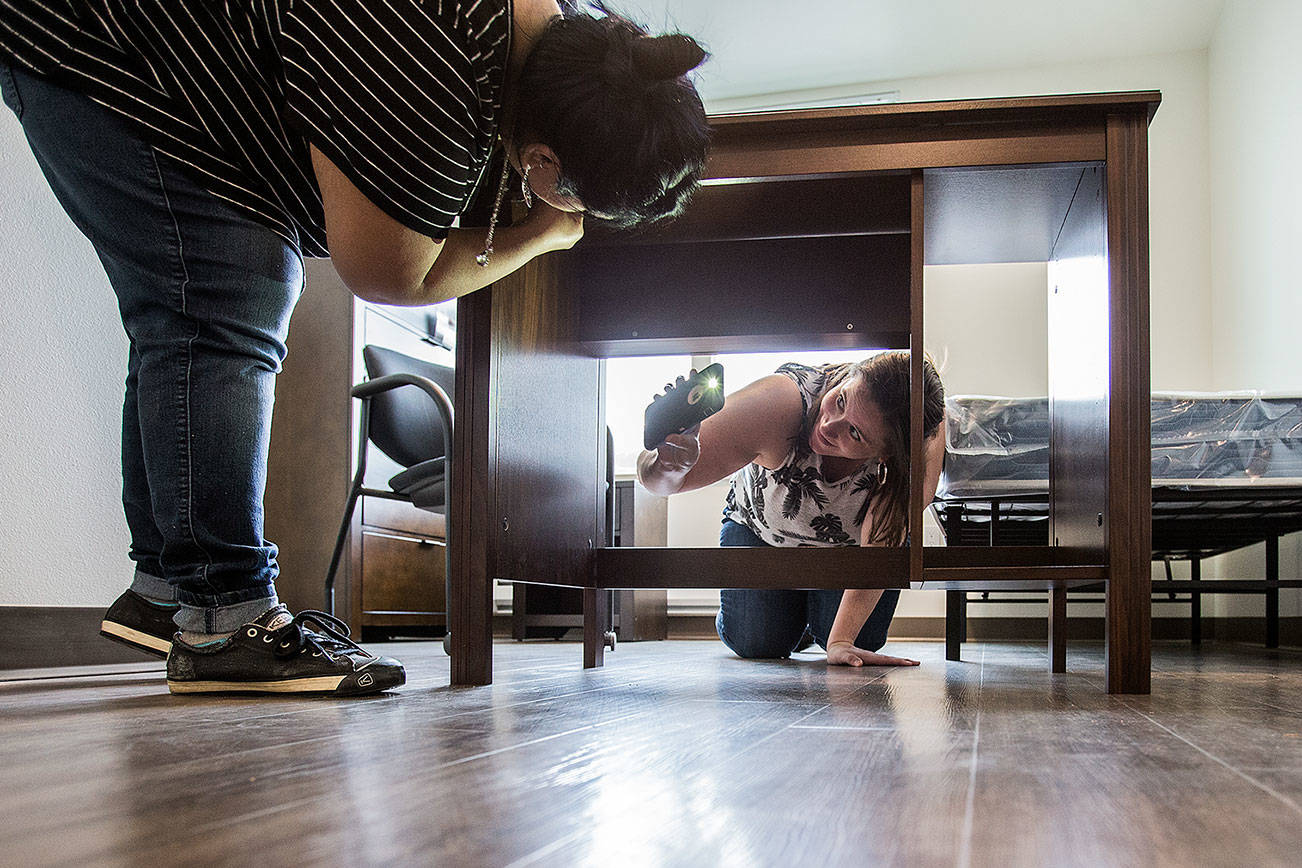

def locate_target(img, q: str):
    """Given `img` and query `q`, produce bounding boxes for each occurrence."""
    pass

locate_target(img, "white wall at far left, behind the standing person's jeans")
[0,108,132,605]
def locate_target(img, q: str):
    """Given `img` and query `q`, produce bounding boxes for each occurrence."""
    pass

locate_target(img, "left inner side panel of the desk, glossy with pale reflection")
[490,256,605,586]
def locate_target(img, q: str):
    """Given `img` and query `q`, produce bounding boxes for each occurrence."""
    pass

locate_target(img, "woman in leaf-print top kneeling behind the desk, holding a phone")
[638,353,945,666]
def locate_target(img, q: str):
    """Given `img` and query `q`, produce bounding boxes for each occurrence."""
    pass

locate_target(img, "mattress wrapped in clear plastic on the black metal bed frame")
[937,392,1302,498]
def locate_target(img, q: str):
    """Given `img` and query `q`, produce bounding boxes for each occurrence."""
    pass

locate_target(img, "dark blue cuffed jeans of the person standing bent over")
[0,65,303,632]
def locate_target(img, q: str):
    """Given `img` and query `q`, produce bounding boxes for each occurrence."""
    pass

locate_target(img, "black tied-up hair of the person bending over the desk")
[512,3,710,228]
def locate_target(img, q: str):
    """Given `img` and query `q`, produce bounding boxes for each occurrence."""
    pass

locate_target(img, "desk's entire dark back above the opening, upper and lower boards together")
[561,172,910,357]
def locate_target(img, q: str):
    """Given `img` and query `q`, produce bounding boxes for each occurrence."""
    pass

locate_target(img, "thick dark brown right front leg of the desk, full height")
[1105,113,1152,694]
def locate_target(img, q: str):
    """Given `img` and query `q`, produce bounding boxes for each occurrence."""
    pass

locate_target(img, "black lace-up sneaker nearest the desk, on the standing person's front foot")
[167,606,406,696]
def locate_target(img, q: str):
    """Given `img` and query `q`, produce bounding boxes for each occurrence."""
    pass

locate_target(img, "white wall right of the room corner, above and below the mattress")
[1208,0,1302,616]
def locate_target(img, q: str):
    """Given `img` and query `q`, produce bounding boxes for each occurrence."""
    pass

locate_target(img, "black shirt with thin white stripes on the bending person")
[0,0,510,256]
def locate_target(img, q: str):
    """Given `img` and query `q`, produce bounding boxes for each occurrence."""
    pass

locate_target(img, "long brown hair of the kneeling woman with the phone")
[799,353,945,545]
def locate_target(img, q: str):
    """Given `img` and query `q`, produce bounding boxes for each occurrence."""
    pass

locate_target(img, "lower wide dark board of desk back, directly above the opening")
[562,233,909,357]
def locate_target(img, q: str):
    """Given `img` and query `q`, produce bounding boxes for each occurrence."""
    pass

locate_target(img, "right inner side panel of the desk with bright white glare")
[1048,167,1111,553]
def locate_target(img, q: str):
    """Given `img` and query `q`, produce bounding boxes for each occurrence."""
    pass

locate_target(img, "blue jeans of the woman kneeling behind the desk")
[715,519,900,657]
